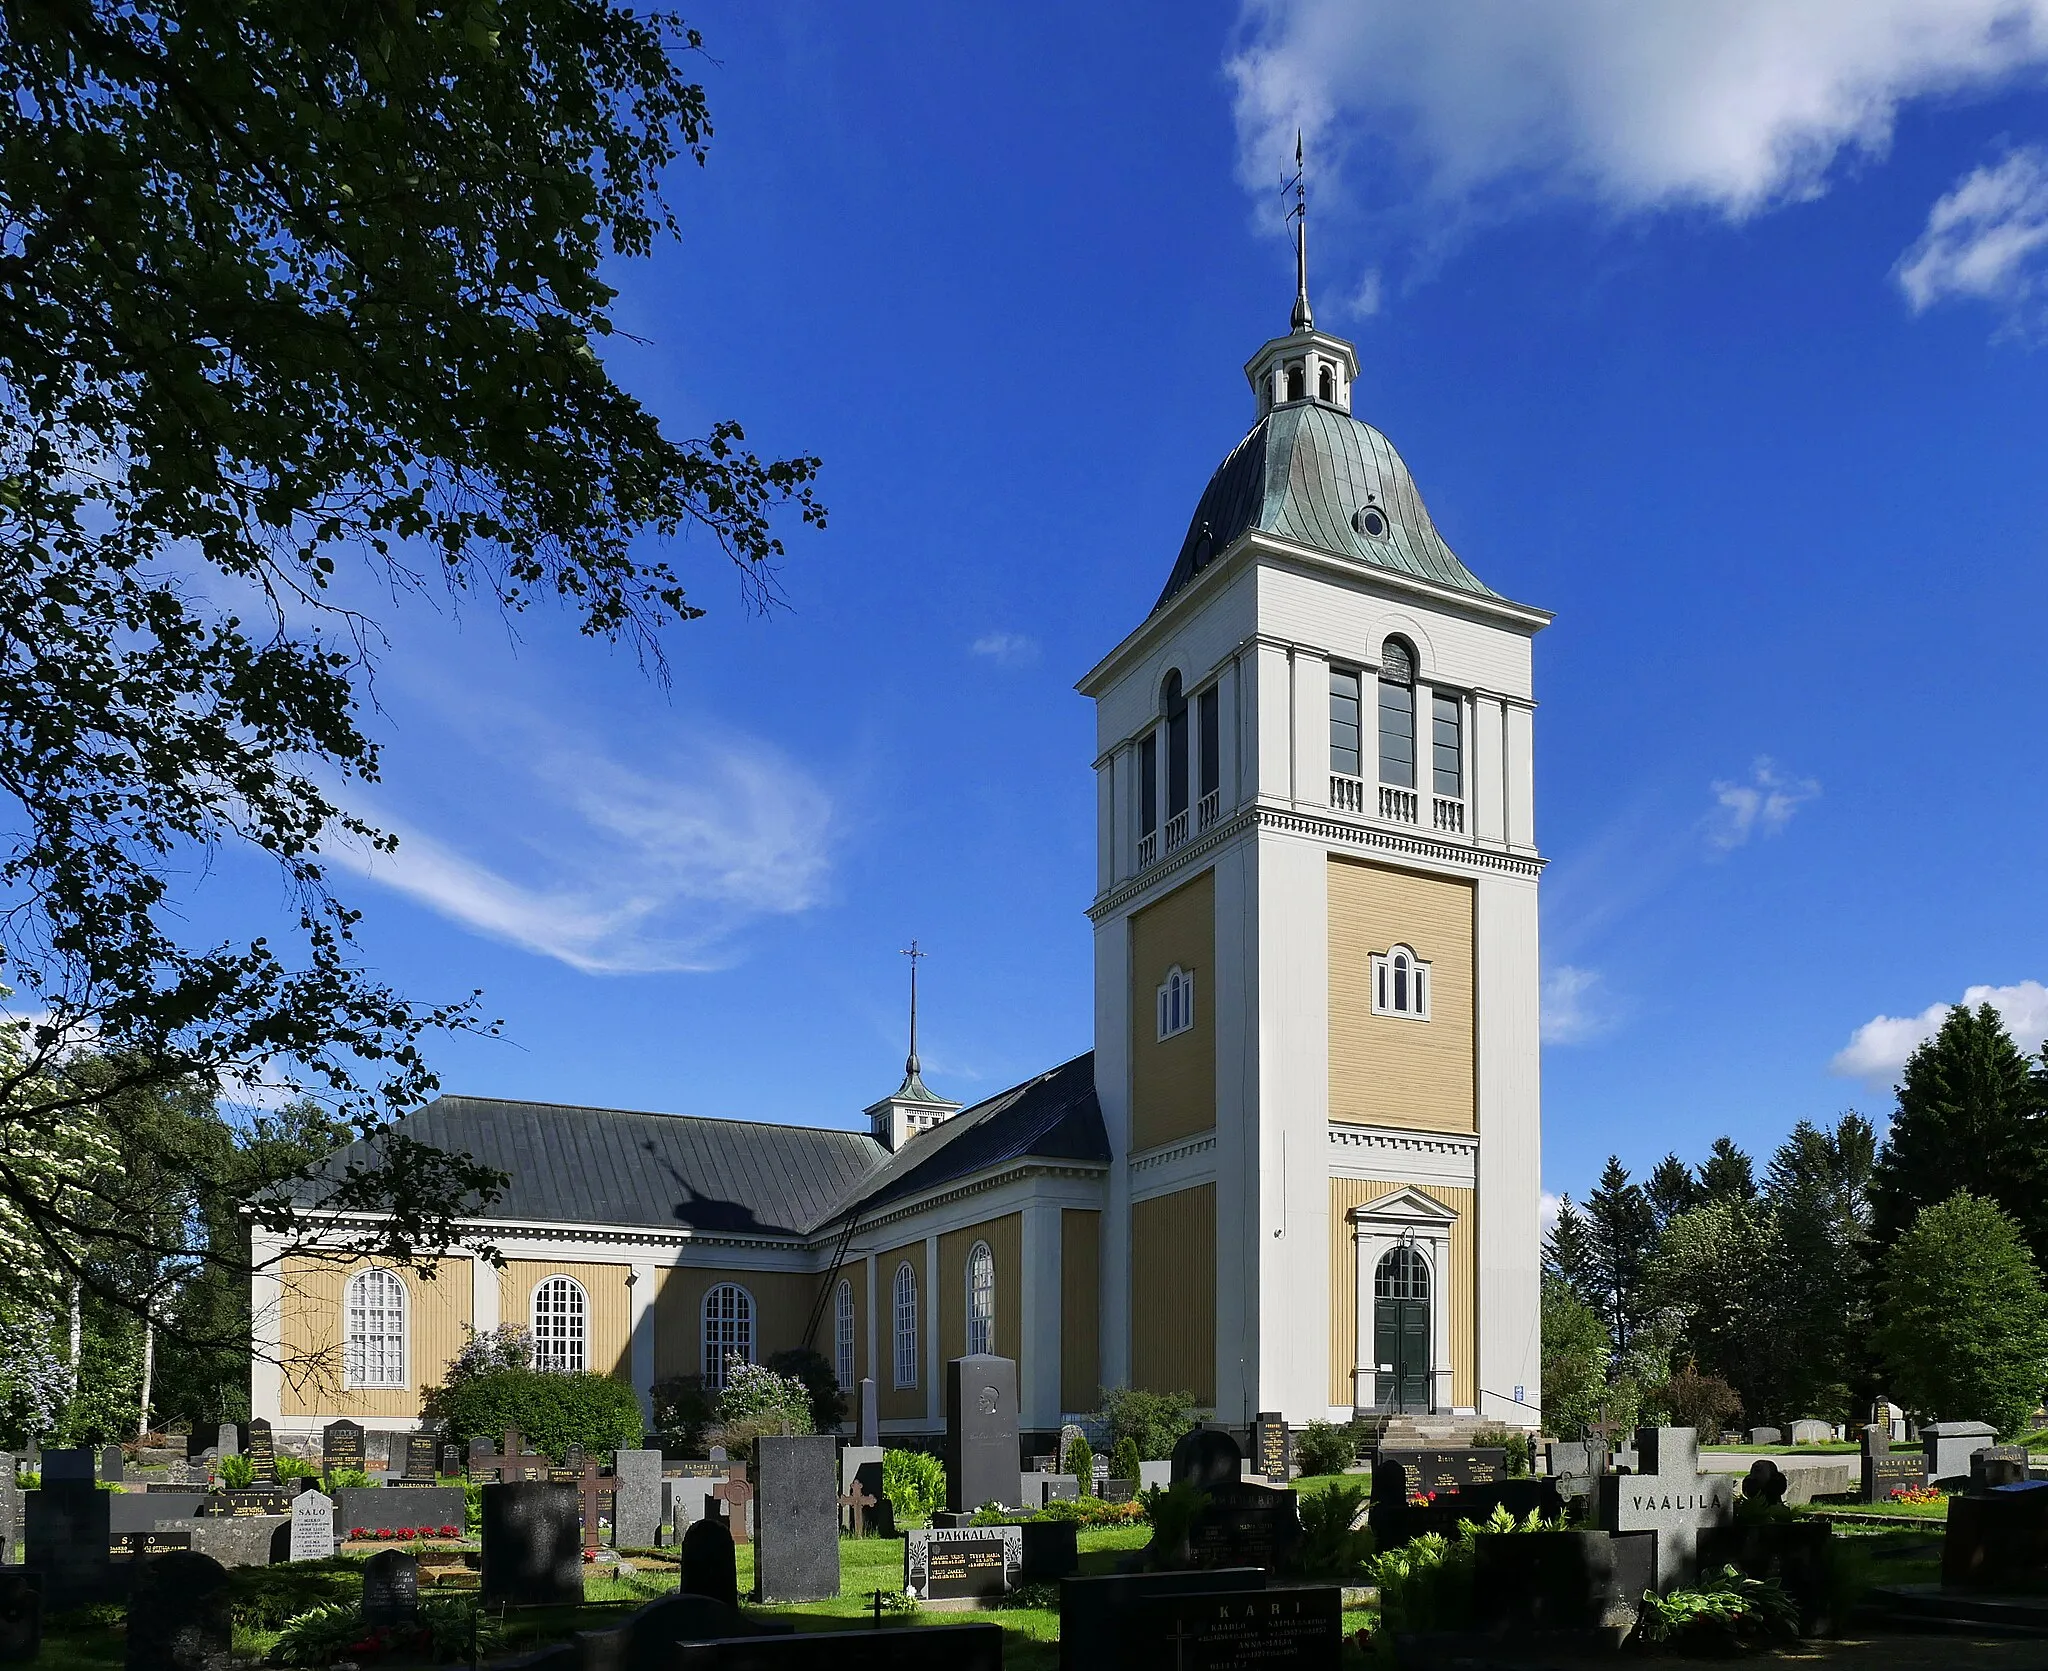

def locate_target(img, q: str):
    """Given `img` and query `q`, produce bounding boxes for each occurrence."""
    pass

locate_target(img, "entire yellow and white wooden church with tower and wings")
[252,233,1550,1436]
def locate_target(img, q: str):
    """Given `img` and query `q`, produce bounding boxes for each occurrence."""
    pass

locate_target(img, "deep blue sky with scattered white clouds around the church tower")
[280,0,2048,1192]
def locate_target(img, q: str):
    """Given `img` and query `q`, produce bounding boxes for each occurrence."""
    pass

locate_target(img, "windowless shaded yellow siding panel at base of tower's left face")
[1130,1184,1217,1405]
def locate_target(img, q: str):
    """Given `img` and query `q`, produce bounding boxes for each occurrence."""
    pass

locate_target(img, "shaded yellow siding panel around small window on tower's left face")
[1130,870,1217,1149]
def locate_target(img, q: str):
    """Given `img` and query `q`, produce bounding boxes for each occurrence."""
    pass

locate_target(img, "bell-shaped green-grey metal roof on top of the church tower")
[1153,401,1499,608]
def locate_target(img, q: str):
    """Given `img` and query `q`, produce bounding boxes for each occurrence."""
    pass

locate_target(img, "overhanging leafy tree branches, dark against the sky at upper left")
[0,0,821,1347]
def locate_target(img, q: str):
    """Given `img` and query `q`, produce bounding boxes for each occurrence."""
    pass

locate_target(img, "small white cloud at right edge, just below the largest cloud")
[1894,145,2048,326]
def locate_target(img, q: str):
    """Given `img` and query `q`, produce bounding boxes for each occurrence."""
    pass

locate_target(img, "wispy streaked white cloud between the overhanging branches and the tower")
[354,727,831,975]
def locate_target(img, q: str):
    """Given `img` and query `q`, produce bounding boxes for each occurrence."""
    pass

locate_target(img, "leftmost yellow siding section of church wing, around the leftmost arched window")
[279,1259,471,1417]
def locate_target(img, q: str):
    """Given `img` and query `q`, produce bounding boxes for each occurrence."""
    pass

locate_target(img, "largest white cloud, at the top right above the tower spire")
[1227,0,2048,219]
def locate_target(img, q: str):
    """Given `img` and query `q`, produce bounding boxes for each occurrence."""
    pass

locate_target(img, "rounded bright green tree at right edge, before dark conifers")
[1878,1190,2048,1433]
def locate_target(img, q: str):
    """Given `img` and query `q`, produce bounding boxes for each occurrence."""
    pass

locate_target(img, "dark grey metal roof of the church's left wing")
[301,1096,889,1235]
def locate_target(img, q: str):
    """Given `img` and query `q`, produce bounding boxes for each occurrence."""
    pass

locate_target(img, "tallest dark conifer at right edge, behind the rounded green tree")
[1870,1003,2048,1261]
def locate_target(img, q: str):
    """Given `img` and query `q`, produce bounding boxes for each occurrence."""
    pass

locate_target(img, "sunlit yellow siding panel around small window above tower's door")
[1329,858,1479,1132]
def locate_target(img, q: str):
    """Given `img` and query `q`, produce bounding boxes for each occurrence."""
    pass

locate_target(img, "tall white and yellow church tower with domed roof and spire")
[1079,205,1550,1425]
